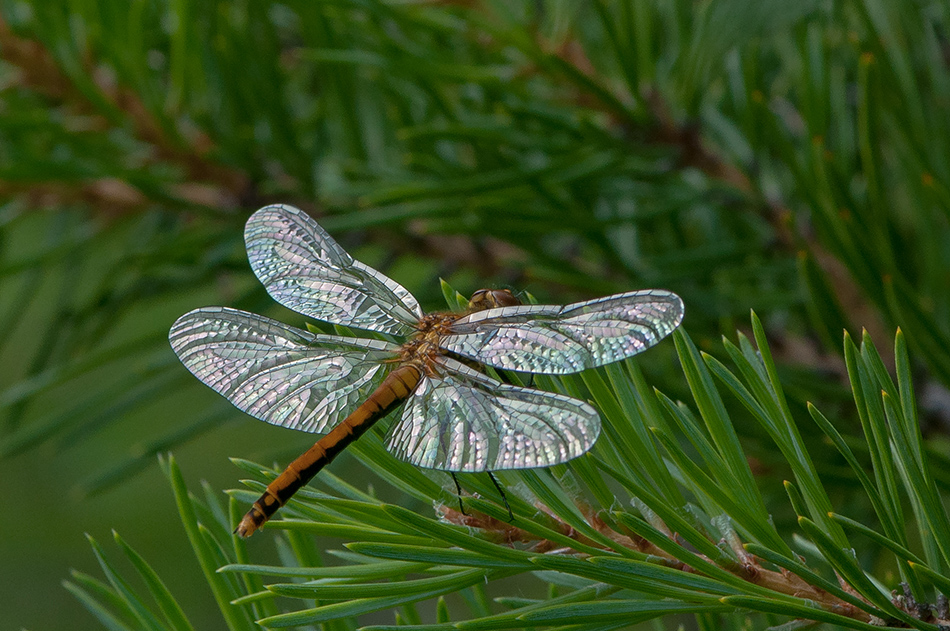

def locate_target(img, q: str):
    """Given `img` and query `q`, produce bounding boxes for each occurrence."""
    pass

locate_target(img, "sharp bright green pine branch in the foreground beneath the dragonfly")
[70,320,950,631]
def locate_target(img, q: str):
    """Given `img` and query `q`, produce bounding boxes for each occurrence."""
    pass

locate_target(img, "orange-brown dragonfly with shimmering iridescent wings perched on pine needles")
[169,204,683,537]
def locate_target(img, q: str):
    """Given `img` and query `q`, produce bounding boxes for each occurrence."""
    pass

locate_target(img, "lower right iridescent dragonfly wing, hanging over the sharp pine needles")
[387,358,600,472]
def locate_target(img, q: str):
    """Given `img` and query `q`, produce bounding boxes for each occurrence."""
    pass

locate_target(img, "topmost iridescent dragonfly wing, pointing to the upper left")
[244,205,422,335]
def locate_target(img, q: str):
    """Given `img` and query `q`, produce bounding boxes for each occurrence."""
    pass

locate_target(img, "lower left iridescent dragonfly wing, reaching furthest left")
[168,307,398,433]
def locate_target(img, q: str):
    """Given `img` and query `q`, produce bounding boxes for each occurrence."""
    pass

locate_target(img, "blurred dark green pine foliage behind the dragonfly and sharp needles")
[0,0,950,625]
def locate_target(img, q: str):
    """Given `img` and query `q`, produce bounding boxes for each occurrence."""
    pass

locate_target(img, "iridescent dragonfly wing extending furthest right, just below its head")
[439,289,683,374]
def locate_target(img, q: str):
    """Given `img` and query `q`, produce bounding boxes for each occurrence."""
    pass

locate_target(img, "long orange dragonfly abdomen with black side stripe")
[234,364,422,537]
